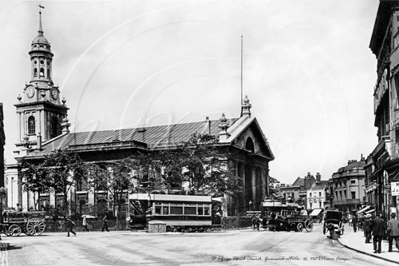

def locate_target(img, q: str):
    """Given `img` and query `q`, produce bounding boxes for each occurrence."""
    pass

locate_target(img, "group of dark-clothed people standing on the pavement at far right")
[352,213,399,253]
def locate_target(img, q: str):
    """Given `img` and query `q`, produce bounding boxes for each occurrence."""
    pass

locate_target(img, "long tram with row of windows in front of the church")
[129,193,212,231]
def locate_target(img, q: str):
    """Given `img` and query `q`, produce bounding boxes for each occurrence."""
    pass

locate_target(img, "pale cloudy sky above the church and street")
[0,0,379,184]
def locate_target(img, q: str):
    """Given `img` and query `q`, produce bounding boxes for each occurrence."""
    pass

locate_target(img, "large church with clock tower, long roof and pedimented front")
[7,9,274,218]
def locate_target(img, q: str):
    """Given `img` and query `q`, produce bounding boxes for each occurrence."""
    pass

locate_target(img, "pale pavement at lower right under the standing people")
[338,224,399,264]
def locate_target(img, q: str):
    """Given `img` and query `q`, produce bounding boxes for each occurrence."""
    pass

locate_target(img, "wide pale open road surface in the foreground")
[0,225,395,266]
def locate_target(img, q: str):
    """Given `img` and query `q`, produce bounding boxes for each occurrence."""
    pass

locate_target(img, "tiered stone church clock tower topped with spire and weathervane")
[15,6,68,149]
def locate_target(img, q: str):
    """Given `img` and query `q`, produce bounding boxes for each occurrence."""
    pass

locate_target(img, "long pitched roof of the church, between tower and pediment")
[42,118,238,152]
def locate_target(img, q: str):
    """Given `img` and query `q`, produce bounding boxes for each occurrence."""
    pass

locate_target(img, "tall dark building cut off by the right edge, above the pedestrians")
[365,1,399,217]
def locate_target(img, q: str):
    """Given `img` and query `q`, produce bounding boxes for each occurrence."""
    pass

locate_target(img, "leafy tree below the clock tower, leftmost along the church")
[21,150,86,215]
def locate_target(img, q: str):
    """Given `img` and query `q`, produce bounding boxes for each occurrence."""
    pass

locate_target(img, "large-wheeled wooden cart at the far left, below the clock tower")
[0,210,46,236]
